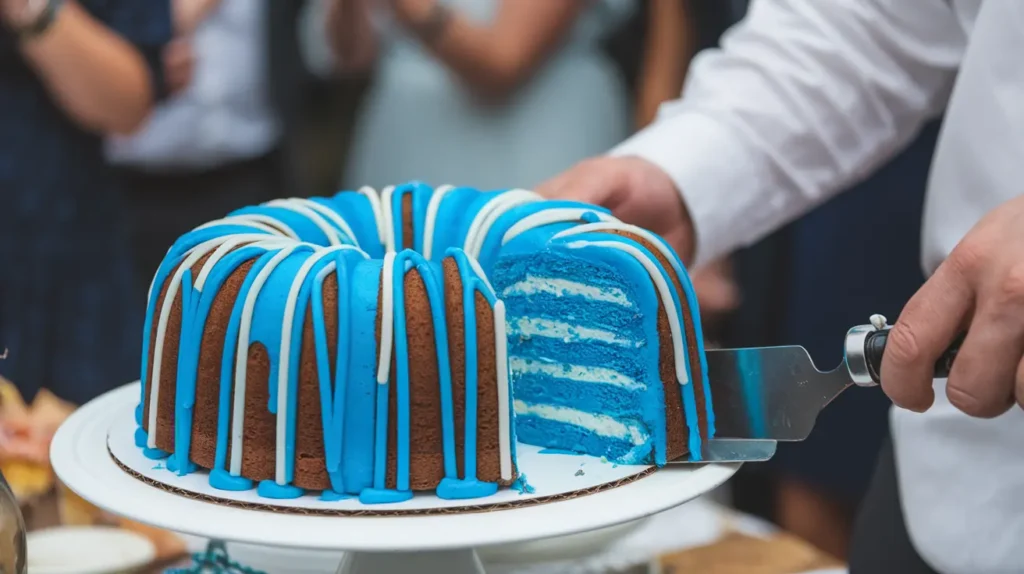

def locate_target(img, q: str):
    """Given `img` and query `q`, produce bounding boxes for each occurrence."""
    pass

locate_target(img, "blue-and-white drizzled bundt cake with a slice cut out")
[135,183,714,503]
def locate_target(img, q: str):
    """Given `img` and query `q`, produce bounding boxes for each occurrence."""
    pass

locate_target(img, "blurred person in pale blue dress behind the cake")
[327,0,634,189]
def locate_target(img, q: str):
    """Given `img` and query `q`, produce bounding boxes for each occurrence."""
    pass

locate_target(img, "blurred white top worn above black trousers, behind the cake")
[106,0,281,169]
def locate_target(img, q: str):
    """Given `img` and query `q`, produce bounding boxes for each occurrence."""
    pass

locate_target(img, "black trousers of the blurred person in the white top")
[119,147,295,301]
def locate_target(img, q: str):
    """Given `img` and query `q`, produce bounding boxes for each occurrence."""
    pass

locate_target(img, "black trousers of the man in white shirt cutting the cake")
[850,438,938,574]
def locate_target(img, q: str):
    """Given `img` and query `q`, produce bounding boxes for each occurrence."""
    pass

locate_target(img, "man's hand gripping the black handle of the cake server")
[881,196,1024,418]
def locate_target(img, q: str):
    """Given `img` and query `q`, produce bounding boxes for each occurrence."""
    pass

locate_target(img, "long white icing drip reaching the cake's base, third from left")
[274,245,366,486]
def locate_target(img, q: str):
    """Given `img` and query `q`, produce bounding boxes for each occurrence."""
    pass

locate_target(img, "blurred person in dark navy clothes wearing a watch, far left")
[0,0,171,404]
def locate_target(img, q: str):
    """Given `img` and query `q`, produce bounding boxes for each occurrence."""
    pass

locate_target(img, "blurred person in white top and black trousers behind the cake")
[106,0,313,298]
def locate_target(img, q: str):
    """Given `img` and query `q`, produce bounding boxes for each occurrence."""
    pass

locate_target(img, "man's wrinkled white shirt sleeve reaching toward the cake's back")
[611,0,967,264]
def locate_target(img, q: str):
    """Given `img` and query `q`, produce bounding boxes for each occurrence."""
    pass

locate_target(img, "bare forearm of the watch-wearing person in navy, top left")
[22,1,154,134]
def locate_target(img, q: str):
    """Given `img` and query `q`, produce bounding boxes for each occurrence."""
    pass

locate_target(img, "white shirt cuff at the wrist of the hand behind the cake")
[609,112,781,266]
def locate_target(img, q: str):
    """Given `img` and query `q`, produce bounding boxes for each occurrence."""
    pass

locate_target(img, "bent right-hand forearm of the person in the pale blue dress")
[405,0,585,97]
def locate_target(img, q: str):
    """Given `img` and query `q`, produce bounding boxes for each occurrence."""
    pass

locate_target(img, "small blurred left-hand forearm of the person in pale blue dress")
[326,0,378,72]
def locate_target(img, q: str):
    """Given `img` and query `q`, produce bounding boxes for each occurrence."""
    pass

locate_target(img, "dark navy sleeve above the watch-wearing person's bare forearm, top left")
[92,0,174,100]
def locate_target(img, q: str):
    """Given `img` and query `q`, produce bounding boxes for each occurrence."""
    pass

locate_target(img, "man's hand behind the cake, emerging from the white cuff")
[537,158,695,262]
